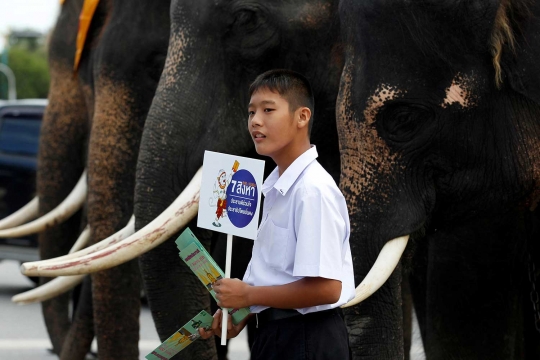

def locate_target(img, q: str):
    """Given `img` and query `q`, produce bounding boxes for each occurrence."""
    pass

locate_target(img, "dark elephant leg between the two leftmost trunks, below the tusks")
[60,276,94,360]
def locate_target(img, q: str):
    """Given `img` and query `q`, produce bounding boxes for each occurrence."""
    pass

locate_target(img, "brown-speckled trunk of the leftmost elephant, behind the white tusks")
[36,56,88,354]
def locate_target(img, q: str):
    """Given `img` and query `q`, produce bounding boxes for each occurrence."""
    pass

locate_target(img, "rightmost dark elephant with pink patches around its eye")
[336,0,540,359]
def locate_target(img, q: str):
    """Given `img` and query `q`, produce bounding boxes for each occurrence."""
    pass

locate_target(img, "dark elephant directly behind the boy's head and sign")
[134,0,342,359]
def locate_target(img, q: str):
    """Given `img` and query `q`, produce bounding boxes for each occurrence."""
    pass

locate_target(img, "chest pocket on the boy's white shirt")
[261,220,289,271]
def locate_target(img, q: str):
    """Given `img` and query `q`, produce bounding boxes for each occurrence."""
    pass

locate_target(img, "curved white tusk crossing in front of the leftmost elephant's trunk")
[0,170,86,238]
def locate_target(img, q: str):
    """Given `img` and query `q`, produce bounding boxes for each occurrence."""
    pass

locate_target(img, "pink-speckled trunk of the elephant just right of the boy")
[336,57,425,359]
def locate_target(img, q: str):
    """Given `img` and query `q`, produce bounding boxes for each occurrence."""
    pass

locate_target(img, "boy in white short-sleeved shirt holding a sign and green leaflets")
[199,70,354,360]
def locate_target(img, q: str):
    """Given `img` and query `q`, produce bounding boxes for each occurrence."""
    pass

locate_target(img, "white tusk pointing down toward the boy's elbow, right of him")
[341,235,409,308]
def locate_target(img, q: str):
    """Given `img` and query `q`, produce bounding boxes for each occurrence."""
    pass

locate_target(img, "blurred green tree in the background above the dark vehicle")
[0,32,50,99]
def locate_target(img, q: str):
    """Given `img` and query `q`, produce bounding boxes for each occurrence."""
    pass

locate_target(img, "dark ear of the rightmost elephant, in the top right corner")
[501,0,540,105]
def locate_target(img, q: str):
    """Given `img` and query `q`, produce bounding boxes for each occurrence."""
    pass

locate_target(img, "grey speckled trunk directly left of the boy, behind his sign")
[135,15,242,359]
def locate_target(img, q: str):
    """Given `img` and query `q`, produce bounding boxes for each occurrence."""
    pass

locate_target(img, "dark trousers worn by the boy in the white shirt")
[251,310,349,360]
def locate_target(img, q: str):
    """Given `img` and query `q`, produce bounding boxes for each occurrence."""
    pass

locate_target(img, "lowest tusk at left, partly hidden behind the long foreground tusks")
[11,226,90,305]
